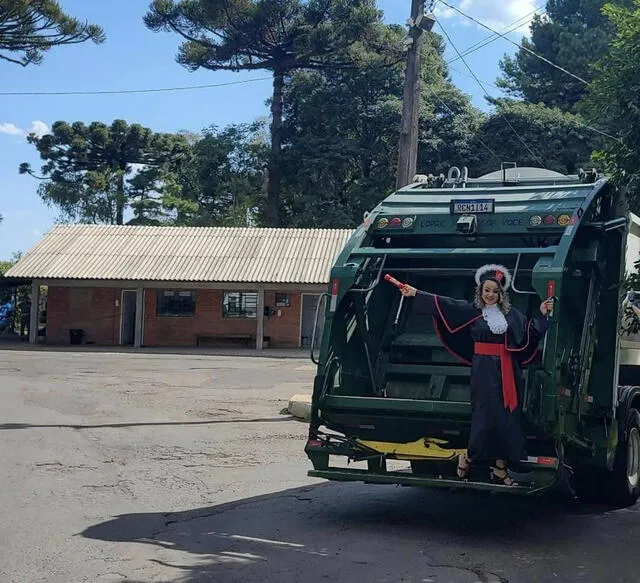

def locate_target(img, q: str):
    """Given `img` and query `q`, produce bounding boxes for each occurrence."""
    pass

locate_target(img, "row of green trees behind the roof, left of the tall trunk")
[20,120,268,226]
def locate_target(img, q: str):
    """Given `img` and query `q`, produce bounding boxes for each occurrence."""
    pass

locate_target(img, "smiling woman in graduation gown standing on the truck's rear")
[400,264,553,486]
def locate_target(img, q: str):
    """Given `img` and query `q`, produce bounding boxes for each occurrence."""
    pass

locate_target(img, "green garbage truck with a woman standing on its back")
[305,164,640,505]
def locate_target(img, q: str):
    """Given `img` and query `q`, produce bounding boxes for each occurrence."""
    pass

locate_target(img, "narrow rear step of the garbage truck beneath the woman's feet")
[307,468,558,496]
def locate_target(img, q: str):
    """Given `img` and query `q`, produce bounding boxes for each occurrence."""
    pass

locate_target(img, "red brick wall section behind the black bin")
[47,286,121,345]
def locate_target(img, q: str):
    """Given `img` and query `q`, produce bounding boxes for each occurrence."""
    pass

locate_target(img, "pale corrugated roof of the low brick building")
[6,225,353,284]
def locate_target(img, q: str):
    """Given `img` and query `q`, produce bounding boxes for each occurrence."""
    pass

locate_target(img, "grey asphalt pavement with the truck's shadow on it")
[0,351,640,583]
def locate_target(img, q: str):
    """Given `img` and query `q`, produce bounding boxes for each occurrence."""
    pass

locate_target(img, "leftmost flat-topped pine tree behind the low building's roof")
[20,120,188,225]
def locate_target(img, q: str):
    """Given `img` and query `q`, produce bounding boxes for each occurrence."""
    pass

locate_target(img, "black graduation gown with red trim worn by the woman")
[415,291,548,461]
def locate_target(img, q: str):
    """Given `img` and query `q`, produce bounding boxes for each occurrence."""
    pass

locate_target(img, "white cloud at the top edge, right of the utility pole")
[436,0,542,36]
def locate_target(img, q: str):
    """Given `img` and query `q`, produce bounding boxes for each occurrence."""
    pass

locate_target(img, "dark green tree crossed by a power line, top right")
[499,0,632,111]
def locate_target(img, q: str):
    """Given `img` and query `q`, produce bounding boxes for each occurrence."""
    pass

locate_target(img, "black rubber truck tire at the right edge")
[607,409,640,507]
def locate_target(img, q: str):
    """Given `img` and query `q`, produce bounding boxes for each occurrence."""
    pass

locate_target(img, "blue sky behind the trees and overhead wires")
[0,0,544,260]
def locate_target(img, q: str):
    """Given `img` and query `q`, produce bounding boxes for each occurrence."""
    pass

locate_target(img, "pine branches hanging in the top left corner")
[0,0,105,67]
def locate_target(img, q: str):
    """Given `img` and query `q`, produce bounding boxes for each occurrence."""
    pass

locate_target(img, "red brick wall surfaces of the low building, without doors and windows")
[47,287,310,348]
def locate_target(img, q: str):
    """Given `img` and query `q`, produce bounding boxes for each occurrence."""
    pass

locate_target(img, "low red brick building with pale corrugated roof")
[7,225,351,349]
